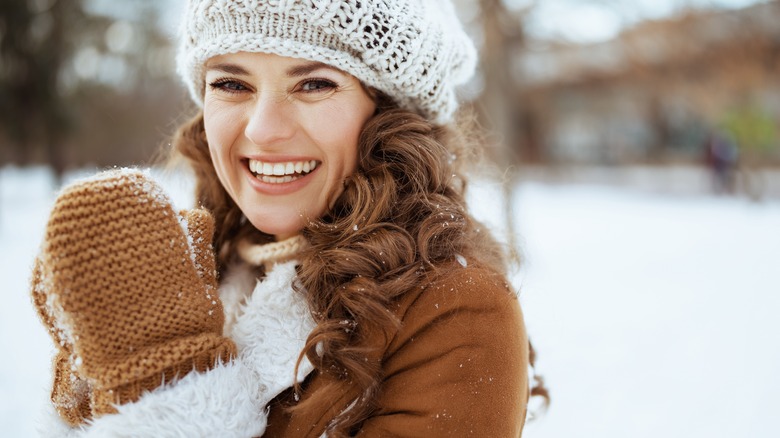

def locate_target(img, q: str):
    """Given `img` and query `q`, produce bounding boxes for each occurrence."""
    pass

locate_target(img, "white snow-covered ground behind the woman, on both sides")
[0,168,780,438]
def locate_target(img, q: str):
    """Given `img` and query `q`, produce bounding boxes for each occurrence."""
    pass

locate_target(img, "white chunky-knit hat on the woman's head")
[177,0,476,123]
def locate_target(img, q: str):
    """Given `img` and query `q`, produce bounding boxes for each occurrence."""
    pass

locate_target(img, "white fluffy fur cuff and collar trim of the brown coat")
[35,261,313,438]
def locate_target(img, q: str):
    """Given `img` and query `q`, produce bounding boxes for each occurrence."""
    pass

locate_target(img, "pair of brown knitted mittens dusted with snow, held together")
[32,170,236,424]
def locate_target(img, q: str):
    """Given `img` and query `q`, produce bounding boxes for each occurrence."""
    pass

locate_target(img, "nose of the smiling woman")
[244,94,295,146]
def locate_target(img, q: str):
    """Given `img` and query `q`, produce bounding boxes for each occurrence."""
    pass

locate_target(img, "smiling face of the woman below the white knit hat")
[203,52,375,240]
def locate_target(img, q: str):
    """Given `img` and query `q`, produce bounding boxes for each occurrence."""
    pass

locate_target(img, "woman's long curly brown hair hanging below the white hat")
[174,94,548,436]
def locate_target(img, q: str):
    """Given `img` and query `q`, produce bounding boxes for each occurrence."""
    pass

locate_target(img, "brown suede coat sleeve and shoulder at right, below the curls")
[359,268,528,437]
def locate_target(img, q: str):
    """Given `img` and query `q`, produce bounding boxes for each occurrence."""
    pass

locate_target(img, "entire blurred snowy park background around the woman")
[0,0,780,437]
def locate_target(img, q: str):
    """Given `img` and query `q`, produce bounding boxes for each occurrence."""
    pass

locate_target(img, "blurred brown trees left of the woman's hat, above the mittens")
[0,0,183,178]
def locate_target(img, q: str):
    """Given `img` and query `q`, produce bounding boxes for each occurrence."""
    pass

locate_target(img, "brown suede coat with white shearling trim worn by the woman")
[44,260,529,438]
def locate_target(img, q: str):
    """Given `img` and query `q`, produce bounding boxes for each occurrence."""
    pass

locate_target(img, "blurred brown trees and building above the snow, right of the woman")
[472,0,780,166]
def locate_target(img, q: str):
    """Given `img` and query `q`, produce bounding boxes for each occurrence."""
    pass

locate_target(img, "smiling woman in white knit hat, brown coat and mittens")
[33,0,544,437]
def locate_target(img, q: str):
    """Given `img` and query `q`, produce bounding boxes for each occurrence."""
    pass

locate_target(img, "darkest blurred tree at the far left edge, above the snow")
[0,0,83,178]
